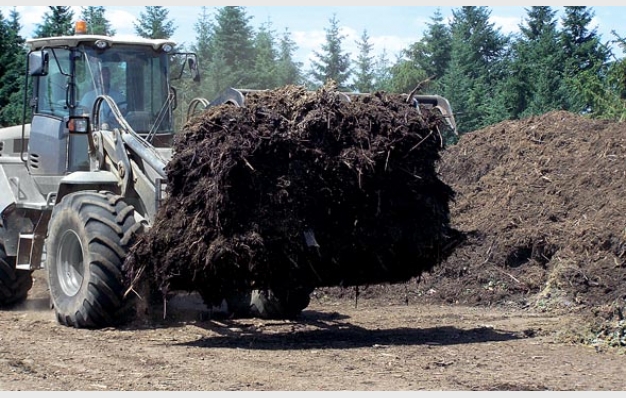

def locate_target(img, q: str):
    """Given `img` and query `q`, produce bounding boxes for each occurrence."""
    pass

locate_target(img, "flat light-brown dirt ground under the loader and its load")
[0,271,626,391]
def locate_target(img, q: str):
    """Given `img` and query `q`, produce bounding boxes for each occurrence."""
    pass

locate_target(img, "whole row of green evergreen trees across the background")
[0,6,626,139]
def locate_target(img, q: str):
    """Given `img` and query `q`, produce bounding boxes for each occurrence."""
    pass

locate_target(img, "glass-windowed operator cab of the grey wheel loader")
[23,35,176,192]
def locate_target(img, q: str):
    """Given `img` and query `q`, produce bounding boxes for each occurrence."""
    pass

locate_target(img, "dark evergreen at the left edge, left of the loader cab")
[0,8,30,126]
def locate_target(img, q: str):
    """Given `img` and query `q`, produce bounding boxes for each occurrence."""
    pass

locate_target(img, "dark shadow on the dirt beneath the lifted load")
[154,311,524,350]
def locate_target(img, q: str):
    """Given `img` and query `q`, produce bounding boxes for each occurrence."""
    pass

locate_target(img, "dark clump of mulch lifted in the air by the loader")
[126,85,463,304]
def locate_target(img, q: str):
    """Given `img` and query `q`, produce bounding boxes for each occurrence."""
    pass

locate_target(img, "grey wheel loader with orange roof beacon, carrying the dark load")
[0,25,453,328]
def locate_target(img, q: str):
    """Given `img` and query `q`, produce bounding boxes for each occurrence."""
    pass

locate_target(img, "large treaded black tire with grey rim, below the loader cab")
[46,192,141,329]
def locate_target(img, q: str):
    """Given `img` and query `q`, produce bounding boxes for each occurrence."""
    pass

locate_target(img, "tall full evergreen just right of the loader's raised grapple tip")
[441,6,509,133]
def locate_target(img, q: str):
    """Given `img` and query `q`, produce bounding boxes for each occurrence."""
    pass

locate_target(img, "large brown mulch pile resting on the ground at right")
[419,112,626,345]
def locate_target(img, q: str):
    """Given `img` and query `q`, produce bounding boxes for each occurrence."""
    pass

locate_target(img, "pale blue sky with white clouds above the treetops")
[0,2,626,68]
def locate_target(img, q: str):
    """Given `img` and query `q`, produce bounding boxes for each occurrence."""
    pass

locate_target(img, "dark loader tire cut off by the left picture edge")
[0,242,33,307]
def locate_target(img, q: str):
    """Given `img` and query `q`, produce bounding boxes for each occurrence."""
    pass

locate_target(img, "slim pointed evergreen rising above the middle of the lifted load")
[310,15,352,89]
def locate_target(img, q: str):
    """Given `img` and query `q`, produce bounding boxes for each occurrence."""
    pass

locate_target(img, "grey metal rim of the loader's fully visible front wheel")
[56,231,85,297]
